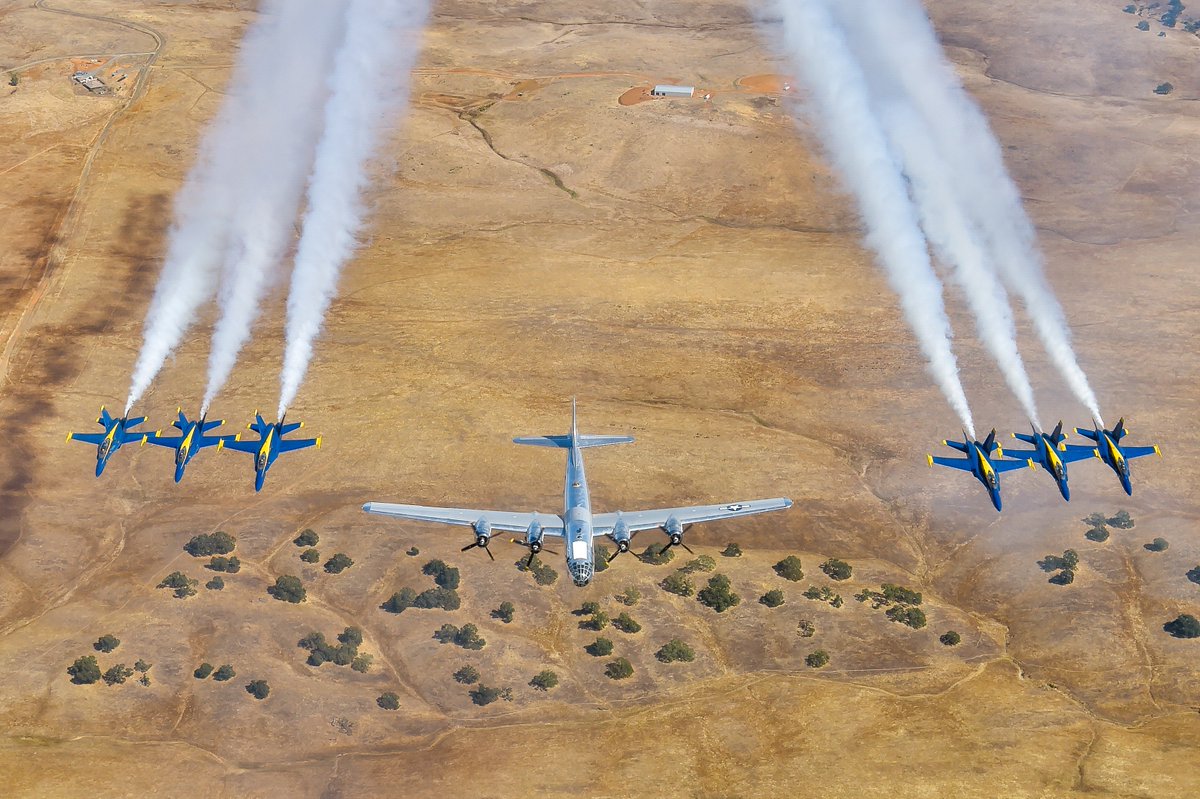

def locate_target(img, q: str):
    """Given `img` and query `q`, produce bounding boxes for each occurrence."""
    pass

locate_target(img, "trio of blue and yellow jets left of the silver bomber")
[67,405,320,492]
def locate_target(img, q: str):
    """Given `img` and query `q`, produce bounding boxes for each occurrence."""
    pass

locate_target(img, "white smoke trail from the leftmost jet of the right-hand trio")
[775,0,976,438]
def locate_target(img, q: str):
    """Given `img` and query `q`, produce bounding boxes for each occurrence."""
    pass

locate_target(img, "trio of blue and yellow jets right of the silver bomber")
[925,417,1162,511]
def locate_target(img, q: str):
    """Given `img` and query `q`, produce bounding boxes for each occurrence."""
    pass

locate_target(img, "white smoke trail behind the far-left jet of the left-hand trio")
[125,0,338,414]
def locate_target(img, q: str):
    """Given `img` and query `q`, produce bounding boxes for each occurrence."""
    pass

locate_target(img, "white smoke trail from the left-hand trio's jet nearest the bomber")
[278,0,428,419]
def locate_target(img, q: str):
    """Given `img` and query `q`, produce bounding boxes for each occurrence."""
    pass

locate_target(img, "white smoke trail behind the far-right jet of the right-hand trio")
[846,0,1103,423]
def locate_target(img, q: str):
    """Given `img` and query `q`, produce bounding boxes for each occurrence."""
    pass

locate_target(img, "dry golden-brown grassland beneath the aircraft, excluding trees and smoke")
[0,0,1200,799]
